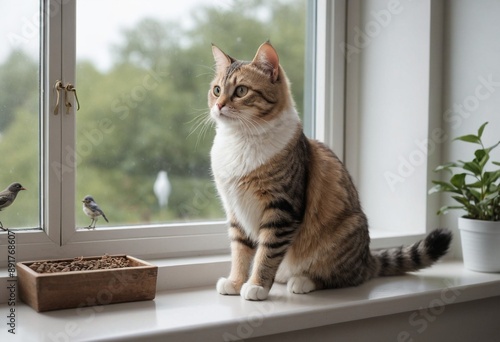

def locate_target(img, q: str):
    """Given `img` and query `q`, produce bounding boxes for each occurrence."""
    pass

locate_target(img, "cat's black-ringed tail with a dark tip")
[372,229,452,276]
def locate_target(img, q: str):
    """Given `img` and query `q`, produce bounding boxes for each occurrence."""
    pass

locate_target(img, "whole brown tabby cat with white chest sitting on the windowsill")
[208,42,452,300]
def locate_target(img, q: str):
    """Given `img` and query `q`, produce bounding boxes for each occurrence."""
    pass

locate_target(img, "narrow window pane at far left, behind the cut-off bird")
[0,0,41,228]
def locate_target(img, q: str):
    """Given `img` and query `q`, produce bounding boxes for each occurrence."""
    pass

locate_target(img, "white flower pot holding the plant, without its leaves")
[458,217,500,272]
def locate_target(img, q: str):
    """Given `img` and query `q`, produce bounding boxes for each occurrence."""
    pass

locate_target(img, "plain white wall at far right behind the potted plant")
[441,0,500,255]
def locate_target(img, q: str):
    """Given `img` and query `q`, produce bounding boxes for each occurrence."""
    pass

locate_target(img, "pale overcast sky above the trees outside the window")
[0,0,231,69]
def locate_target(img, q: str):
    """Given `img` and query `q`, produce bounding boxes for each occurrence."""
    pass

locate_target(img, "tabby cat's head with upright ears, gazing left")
[208,42,295,133]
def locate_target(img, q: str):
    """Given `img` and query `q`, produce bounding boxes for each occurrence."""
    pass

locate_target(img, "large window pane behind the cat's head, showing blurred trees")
[76,0,306,227]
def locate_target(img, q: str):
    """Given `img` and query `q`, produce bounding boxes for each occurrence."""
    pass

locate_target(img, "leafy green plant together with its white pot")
[429,122,500,272]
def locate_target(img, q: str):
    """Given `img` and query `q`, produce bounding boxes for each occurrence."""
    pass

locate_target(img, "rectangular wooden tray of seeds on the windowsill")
[17,255,158,312]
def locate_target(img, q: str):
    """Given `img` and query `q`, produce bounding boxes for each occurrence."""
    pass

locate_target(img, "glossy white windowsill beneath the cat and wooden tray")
[0,261,500,341]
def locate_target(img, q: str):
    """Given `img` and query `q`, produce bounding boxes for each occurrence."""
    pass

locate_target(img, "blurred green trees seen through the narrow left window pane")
[0,51,40,228]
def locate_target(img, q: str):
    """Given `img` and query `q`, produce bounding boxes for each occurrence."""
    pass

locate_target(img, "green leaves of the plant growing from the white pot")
[429,122,500,221]
